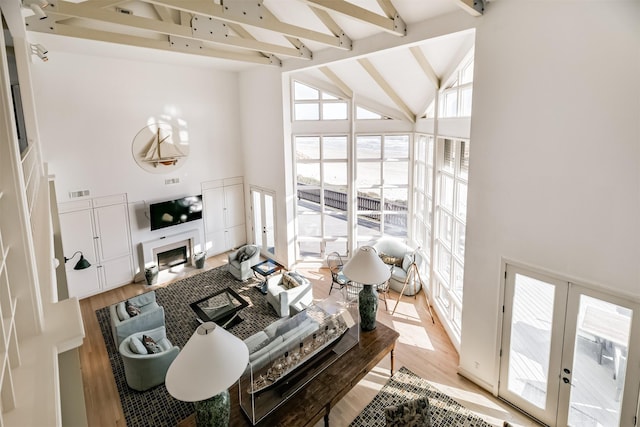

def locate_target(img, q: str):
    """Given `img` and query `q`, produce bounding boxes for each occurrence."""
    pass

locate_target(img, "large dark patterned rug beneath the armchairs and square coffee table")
[96,266,278,427]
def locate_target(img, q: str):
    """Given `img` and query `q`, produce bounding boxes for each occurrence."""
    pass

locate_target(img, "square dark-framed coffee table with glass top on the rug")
[189,288,249,329]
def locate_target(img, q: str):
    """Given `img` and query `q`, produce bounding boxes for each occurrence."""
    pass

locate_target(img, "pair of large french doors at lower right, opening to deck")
[498,265,640,427]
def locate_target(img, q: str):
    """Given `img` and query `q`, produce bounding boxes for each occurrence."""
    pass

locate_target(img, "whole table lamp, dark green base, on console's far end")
[342,246,391,331]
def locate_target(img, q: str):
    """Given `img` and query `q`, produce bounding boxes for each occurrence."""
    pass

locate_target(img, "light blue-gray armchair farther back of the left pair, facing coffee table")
[109,291,164,347]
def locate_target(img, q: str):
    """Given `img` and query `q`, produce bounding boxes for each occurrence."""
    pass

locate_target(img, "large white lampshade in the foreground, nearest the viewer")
[165,322,249,402]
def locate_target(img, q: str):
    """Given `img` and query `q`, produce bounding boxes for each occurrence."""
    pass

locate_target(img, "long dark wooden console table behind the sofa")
[180,322,400,427]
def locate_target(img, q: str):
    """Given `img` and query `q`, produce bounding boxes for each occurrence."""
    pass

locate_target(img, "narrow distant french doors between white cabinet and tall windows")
[251,187,276,258]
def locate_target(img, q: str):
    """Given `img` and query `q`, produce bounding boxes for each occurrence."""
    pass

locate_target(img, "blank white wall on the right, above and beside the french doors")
[460,0,640,387]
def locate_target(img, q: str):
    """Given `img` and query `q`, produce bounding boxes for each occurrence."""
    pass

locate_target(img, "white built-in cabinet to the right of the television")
[202,177,247,255]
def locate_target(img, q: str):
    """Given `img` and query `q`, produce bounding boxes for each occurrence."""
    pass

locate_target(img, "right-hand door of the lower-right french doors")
[558,285,638,427]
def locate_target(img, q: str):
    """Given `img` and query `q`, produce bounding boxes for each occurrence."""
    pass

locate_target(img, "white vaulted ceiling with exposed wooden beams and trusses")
[16,0,484,121]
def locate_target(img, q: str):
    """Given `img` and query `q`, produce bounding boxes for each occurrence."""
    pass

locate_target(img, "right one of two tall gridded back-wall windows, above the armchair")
[355,135,410,242]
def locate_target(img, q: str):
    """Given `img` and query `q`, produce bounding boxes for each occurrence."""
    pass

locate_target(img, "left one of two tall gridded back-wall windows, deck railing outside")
[294,135,349,259]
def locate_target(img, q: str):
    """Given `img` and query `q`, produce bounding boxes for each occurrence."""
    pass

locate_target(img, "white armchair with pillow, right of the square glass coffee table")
[267,271,313,317]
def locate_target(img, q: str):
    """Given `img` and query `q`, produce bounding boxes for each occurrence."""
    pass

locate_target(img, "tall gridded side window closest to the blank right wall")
[433,138,469,332]
